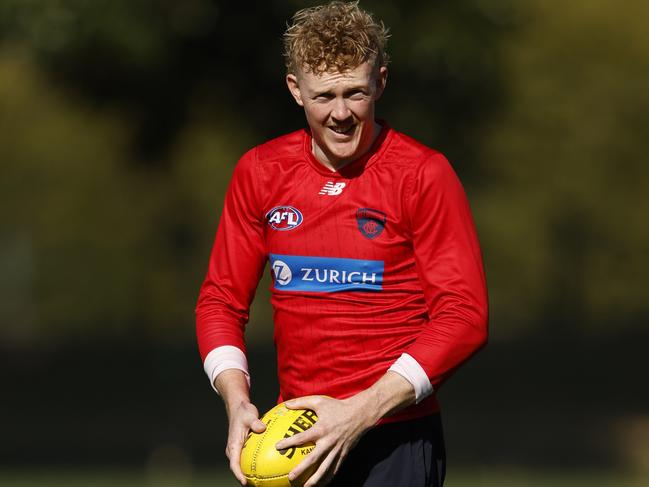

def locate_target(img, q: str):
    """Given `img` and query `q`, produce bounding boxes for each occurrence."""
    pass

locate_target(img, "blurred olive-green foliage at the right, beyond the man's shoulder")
[473,0,649,338]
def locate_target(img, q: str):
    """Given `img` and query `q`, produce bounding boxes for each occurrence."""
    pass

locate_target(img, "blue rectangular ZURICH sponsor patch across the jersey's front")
[270,254,384,292]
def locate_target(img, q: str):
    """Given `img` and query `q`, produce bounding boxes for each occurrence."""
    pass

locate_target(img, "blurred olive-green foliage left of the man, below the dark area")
[0,51,243,342]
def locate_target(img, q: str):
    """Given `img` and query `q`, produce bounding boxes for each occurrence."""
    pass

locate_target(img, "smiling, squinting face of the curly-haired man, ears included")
[286,62,388,170]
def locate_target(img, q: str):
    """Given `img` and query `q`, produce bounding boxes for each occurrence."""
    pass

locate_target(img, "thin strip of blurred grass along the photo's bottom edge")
[0,470,649,487]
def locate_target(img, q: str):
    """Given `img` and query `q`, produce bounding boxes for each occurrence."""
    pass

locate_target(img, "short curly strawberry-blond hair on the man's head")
[284,1,389,74]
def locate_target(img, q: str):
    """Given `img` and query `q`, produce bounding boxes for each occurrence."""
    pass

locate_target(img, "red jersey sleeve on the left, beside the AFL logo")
[196,149,266,361]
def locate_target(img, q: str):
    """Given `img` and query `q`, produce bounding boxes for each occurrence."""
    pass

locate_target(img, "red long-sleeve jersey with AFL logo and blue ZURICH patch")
[197,125,487,420]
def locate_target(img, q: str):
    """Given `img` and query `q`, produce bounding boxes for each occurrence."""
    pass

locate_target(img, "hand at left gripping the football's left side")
[225,401,266,485]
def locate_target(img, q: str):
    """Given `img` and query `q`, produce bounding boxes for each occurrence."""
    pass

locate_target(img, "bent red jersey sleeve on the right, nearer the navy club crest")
[405,153,488,388]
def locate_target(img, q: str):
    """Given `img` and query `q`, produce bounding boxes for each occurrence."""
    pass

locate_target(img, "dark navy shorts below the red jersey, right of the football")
[329,414,446,487]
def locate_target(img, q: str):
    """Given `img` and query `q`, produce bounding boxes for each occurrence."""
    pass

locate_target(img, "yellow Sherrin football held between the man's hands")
[241,403,318,487]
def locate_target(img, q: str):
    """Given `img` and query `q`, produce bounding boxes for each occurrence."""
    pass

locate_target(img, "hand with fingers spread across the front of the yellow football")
[276,396,376,487]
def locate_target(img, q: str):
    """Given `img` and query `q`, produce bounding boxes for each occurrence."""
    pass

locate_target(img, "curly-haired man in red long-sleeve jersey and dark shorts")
[197,2,487,487]
